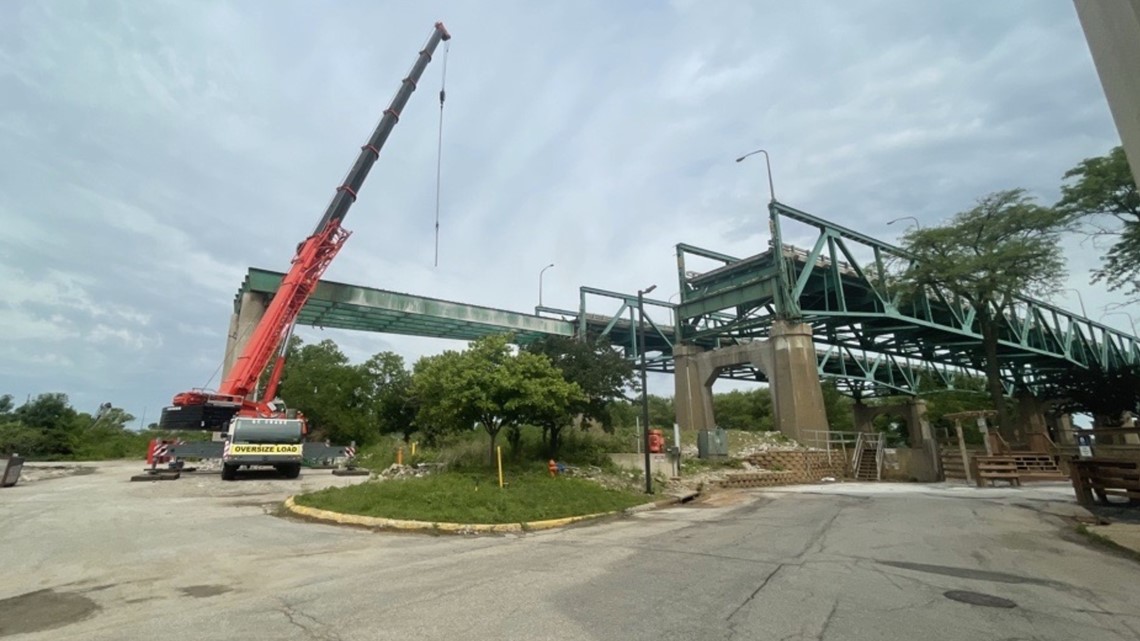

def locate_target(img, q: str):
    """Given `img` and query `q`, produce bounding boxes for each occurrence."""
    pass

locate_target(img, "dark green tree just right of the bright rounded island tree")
[523,336,635,456]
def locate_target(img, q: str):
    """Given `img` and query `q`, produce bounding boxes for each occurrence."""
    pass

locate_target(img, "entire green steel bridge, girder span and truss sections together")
[235,202,1140,398]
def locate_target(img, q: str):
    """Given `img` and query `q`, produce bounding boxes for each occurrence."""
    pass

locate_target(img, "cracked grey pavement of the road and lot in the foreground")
[0,463,1140,641]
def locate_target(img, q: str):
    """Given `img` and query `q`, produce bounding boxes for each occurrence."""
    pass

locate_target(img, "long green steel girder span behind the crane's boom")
[243,268,575,343]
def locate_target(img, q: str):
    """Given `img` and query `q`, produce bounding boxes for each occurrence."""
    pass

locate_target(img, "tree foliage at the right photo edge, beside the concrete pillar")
[1057,147,1140,301]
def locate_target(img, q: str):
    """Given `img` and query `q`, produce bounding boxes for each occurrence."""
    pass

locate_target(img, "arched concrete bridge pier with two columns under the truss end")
[674,321,828,449]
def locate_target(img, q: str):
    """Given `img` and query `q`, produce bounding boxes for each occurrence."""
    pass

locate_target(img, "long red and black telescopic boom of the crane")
[167,23,451,413]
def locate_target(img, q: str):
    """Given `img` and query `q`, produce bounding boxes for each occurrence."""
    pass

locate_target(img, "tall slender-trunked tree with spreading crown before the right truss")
[902,189,1067,439]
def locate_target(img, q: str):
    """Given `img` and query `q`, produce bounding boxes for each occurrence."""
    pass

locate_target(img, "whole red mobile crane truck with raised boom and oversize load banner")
[160,23,451,451]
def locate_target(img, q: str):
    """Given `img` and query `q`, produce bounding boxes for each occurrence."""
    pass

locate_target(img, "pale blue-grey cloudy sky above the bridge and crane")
[0,0,1121,422]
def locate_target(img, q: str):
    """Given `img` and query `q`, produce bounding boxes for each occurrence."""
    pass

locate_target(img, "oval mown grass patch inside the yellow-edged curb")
[294,471,646,524]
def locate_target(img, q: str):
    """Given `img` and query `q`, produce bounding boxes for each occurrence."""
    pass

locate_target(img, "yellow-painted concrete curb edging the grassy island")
[285,492,697,534]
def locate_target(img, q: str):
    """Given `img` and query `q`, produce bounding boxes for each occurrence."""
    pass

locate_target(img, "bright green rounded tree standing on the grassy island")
[413,336,583,462]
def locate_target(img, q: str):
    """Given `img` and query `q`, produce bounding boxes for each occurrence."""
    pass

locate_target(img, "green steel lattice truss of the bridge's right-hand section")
[677,202,1140,396]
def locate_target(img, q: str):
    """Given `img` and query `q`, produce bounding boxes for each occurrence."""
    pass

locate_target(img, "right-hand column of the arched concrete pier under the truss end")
[765,321,829,441]
